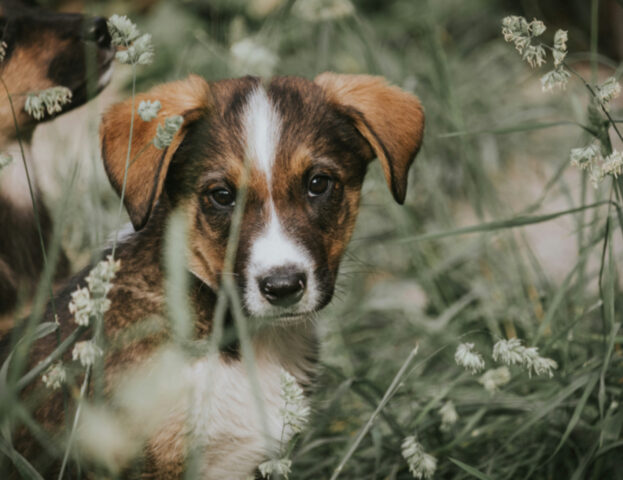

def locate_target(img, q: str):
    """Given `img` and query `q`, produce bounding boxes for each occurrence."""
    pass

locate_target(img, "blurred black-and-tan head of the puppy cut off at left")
[0,0,114,135]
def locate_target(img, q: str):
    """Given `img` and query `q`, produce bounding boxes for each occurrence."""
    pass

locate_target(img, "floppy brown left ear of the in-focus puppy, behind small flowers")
[100,75,210,230]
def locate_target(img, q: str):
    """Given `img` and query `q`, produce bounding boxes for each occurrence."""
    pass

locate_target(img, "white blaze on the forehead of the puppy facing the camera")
[244,86,281,185]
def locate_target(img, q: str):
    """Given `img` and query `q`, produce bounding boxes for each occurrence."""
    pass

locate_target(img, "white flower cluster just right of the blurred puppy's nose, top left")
[108,15,154,65]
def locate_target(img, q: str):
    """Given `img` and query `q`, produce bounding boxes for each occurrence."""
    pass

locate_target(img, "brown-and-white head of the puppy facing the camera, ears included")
[101,73,424,317]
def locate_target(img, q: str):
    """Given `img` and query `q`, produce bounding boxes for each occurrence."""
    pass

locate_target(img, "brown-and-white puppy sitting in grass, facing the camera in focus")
[7,73,424,480]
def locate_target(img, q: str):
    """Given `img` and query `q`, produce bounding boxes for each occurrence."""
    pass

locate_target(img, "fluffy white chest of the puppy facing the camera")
[183,350,304,480]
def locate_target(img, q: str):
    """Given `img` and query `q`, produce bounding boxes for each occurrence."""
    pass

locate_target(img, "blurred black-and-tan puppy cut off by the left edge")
[0,1,114,314]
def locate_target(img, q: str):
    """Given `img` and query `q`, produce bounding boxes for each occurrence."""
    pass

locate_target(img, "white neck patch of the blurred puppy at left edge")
[0,140,38,213]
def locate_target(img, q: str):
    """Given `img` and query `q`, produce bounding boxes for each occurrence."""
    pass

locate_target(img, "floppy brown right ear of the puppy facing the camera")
[314,72,424,204]
